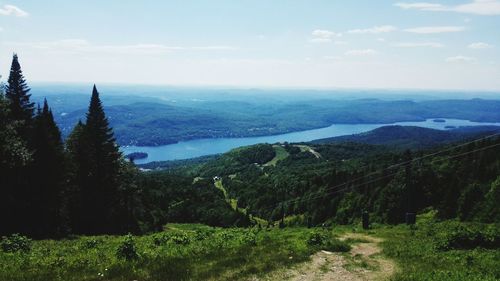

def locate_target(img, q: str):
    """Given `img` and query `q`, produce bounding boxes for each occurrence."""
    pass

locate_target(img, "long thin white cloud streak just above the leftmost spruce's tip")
[7,39,237,55]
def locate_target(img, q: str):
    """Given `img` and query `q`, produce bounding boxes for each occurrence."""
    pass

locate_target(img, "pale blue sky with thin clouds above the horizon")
[0,0,500,91]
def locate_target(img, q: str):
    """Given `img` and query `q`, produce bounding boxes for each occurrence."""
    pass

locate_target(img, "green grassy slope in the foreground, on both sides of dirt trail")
[0,217,500,281]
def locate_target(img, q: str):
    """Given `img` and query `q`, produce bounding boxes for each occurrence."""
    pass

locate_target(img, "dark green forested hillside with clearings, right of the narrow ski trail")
[188,134,500,225]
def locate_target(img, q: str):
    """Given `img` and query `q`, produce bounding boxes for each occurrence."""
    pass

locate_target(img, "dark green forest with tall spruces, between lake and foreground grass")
[0,55,500,238]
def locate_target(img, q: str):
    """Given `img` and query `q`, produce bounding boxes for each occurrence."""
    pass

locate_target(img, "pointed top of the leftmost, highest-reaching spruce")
[6,54,34,127]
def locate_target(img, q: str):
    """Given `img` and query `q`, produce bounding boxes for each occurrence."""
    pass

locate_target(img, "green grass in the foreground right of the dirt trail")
[377,214,500,281]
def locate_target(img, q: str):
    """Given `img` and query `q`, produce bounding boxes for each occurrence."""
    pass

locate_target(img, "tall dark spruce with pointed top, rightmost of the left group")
[72,85,121,234]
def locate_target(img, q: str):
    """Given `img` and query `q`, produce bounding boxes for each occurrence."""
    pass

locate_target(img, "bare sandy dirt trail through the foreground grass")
[261,233,396,281]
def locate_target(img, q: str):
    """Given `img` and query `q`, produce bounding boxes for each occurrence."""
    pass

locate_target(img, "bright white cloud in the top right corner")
[394,0,500,16]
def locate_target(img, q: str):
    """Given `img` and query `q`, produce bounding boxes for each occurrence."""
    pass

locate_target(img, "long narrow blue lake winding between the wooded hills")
[120,118,500,164]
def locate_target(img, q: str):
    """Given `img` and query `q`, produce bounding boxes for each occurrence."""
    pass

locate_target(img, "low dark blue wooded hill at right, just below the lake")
[311,123,500,149]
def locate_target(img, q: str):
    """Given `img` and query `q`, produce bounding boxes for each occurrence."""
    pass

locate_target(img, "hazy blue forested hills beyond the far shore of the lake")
[35,92,500,146]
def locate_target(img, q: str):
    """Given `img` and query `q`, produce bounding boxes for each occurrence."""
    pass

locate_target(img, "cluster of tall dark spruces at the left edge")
[0,54,138,237]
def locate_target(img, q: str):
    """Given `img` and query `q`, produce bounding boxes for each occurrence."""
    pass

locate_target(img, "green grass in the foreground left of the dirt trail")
[0,224,352,281]
